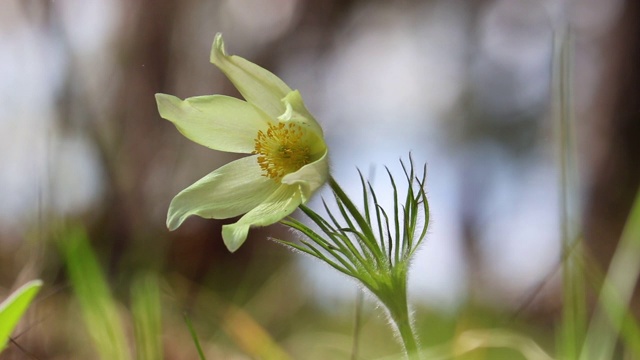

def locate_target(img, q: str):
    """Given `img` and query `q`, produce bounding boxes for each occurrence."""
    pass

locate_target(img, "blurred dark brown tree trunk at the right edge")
[585,0,640,312]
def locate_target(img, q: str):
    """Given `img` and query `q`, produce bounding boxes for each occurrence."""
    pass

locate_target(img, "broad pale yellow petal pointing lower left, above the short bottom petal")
[167,156,282,230]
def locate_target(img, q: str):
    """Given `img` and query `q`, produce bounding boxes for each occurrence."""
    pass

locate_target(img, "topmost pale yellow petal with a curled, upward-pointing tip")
[211,33,291,119]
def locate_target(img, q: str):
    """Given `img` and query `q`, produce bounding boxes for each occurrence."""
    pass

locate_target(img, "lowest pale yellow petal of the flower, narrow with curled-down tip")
[222,185,302,252]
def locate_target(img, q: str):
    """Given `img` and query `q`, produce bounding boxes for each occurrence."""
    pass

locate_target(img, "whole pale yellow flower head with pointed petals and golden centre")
[156,34,328,251]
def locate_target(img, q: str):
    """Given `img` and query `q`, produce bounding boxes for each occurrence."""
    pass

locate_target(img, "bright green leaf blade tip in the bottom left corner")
[0,280,42,352]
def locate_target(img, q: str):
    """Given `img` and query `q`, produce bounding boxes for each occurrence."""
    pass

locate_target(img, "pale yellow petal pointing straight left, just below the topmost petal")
[156,94,268,154]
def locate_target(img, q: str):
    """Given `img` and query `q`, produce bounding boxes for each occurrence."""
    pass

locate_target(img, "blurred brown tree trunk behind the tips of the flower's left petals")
[92,0,180,268]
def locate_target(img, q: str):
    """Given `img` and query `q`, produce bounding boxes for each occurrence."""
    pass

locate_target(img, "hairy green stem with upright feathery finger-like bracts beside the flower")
[275,155,429,359]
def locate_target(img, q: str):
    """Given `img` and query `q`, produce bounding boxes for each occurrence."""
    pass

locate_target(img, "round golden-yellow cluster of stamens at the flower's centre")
[253,122,311,180]
